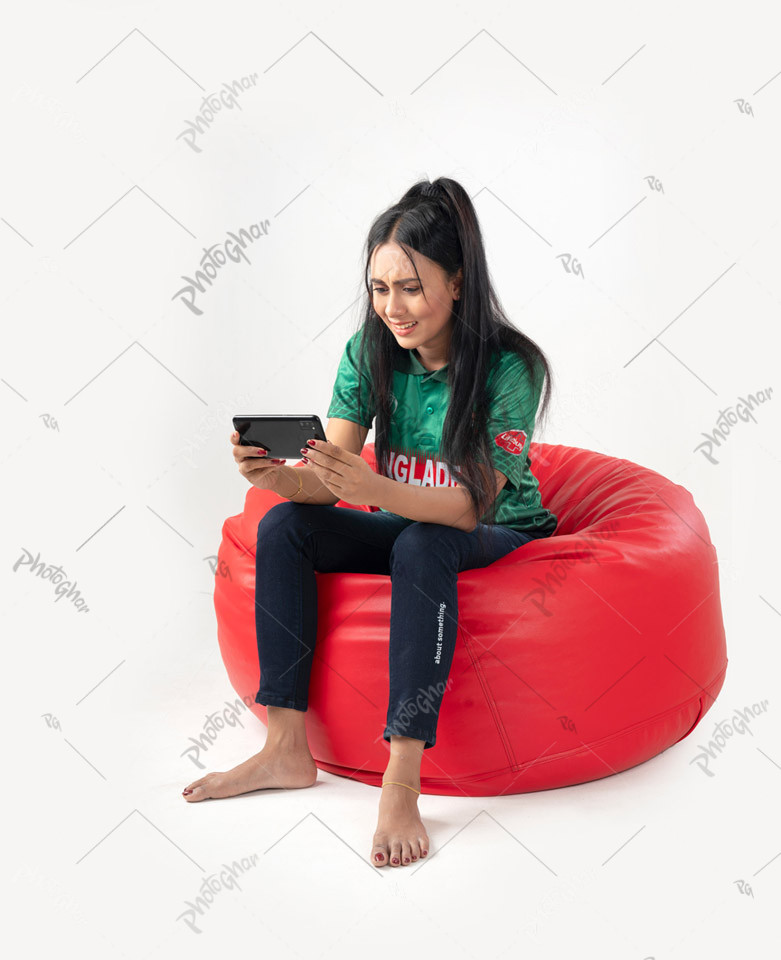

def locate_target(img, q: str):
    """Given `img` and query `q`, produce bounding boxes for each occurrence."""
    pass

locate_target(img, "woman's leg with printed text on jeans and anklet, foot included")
[371,522,533,867]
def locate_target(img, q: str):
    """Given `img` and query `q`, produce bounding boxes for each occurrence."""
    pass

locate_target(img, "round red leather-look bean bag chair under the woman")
[214,443,727,796]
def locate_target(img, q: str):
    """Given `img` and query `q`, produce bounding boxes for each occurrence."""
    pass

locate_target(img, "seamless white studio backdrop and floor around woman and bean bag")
[0,0,781,960]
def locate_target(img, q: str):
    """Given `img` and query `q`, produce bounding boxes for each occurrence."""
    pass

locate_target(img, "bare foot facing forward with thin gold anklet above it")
[371,776,428,867]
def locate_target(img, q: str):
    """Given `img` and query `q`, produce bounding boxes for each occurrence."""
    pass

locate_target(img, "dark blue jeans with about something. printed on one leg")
[255,500,534,749]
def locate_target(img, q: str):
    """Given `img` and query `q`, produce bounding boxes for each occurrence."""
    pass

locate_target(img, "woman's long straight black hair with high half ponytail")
[350,177,552,548]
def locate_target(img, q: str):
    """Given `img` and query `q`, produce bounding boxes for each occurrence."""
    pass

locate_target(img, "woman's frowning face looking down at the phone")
[370,243,461,357]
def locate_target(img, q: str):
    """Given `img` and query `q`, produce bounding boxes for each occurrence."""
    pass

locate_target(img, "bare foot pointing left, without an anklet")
[182,744,316,803]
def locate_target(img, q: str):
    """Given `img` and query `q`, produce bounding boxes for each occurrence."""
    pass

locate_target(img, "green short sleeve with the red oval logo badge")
[476,354,543,491]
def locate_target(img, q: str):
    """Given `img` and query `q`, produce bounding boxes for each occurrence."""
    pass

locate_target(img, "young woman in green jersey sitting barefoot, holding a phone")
[184,177,557,866]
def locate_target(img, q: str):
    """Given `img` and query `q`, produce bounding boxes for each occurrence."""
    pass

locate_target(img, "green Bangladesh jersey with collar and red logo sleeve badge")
[327,330,558,537]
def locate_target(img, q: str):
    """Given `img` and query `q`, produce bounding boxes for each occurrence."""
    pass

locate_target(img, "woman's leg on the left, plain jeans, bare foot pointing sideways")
[183,500,412,801]
